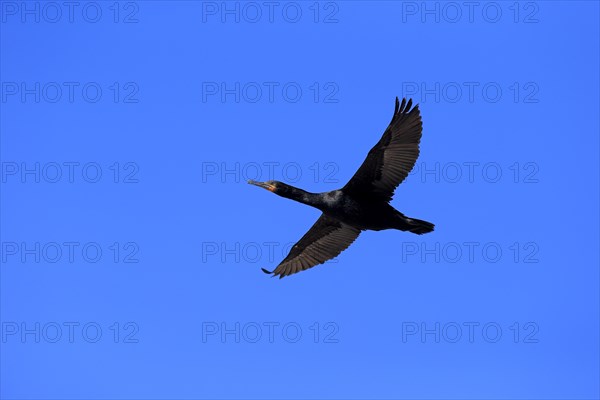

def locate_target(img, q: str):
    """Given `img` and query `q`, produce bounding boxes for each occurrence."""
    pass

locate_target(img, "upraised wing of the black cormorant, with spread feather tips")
[342,97,423,201]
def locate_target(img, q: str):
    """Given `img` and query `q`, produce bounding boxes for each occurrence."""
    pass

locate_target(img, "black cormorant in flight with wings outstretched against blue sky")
[248,97,434,278]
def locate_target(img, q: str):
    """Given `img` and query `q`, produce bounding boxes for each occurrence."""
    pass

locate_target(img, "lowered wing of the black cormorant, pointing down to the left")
[263,214,360,278]
